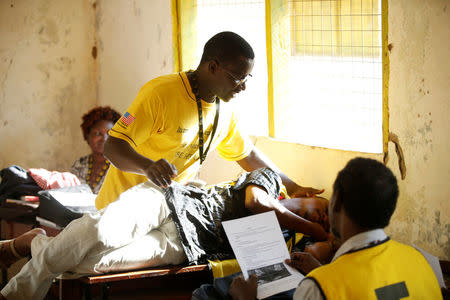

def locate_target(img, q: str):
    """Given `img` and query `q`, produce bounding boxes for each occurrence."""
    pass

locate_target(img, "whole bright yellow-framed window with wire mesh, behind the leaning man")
[174,0,386,153]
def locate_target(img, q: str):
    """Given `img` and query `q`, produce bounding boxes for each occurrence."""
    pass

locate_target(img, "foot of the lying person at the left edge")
[0,228,46,268]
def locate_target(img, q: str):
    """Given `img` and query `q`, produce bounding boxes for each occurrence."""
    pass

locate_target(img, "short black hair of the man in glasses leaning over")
[200,31,255,63]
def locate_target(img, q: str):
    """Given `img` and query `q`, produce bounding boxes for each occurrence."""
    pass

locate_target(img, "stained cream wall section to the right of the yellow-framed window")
[389,0,450,259]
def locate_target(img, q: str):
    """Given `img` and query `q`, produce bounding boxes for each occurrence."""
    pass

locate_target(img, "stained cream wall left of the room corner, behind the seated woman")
[0,0,96,170]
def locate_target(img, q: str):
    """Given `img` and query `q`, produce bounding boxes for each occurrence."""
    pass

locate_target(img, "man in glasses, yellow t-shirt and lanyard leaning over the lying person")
[96,32,326,239]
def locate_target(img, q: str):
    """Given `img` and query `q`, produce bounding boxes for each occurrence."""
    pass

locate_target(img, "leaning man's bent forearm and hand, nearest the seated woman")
[103,136,177,187]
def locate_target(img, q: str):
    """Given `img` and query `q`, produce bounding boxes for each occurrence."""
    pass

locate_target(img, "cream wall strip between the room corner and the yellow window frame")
[97,0,173,113]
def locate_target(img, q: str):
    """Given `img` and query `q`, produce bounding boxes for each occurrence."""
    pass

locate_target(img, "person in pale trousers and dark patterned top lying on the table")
[0,168,328,300]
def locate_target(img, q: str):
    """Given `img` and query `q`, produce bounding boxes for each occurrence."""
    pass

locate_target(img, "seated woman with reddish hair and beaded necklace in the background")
[70,106,120,194]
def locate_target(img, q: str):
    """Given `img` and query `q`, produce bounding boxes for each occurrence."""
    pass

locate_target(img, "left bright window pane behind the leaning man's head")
[196,0,268,136]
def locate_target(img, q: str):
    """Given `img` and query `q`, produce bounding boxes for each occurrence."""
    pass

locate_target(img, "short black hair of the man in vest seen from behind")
[333,157,398,229]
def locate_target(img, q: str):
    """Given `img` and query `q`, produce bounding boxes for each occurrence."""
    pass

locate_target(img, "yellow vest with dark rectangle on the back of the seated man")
[307,240,442,300]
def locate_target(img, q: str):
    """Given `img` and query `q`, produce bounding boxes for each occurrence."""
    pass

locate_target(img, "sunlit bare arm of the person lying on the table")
[245,185,327,241]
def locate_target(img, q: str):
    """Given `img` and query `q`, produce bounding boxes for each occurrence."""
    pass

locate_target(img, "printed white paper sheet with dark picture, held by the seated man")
[222,211,304,299]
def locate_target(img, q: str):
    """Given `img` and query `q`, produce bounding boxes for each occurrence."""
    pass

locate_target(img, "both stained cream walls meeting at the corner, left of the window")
[0,0,173,171]
